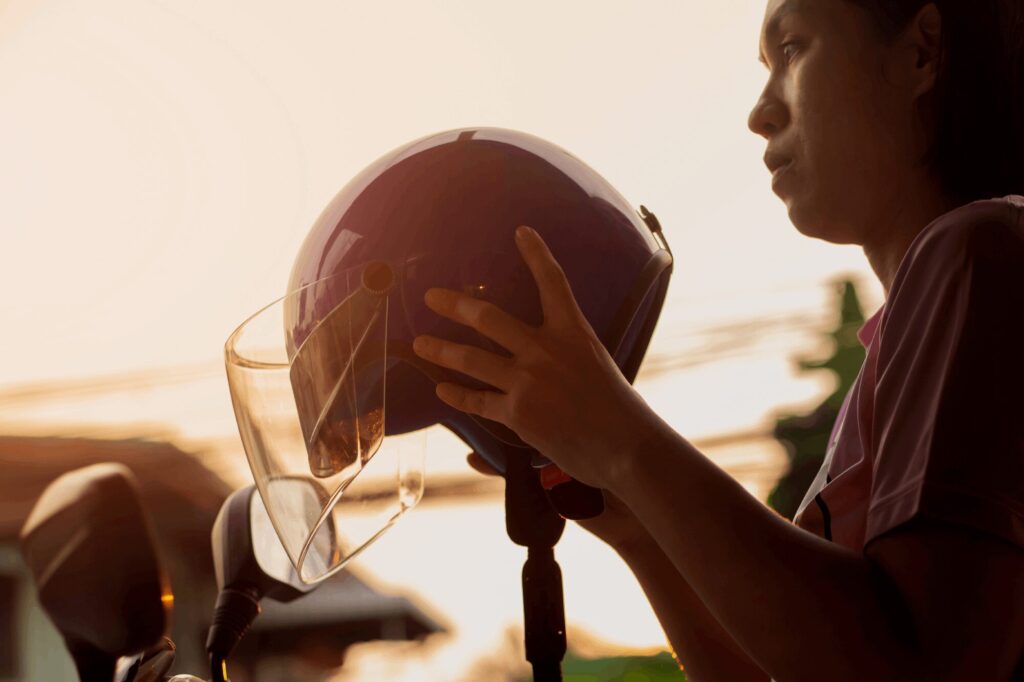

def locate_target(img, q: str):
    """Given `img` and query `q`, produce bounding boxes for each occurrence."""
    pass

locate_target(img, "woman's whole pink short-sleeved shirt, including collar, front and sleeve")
[795,196,1024,551]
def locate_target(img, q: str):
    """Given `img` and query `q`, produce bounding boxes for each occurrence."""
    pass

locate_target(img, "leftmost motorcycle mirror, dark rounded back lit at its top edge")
[20,463,174,682]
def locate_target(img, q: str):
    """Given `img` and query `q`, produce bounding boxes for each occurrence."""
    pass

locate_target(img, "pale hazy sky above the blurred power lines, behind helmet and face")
[0,0,880,384]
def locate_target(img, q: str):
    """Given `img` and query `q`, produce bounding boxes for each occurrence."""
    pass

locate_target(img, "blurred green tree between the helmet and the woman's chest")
[768,279,864,518]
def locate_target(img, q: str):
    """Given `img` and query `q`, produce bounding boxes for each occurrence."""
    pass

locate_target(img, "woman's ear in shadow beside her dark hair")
[890,2,942,99]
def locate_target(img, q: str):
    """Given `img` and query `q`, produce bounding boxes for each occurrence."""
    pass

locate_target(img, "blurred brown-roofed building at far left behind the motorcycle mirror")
[0,436,230,681]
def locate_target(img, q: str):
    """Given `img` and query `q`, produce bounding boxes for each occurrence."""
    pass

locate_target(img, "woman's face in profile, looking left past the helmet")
[749,0,927,244]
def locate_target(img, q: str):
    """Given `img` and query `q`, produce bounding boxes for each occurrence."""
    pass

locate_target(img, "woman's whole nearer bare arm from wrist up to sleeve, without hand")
[613,424,1024,682]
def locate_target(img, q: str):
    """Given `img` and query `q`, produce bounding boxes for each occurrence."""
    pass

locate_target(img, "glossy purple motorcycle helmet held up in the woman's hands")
[228,128,673,572]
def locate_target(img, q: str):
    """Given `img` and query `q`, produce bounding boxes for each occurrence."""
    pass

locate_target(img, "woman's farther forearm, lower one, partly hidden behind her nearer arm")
[620,541,768,682]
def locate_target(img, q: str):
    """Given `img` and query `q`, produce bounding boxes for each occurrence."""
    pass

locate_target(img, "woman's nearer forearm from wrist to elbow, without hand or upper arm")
[612,423,920,681]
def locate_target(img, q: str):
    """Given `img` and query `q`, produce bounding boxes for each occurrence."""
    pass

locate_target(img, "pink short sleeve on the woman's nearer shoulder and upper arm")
[864,206,1024,547]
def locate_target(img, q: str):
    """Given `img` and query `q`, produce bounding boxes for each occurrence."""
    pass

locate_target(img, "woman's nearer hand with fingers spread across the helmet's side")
[414,226,660,488]
